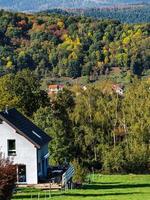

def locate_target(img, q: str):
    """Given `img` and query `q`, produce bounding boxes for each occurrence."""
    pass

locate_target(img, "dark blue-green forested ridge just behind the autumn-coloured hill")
[44,5,150,24]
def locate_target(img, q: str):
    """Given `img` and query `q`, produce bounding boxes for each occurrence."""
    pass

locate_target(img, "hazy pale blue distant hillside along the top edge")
[0,0,150,11]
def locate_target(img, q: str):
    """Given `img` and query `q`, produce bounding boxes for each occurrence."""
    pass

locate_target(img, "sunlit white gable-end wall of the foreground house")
[0,122,38,184]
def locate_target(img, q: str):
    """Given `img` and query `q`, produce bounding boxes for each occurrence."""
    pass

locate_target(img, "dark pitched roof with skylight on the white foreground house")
[0,108,51,148]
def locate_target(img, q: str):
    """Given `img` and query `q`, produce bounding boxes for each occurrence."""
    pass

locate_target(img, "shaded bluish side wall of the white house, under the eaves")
[38,144,48,177]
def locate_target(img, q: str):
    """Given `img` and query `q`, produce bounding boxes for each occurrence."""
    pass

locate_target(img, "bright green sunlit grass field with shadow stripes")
[13,175,150,200]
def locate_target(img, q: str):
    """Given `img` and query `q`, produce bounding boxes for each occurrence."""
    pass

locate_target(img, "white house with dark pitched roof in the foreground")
[0,109,51,184]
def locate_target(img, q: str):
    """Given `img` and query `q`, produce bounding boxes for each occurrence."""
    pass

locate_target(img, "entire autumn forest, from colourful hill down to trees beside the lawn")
[0,11,150,175]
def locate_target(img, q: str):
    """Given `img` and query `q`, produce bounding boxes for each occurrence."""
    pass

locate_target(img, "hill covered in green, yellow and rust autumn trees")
[0,11,150,78]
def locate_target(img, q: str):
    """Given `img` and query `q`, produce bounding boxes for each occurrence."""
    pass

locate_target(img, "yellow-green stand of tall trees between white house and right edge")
[33,79,150,173]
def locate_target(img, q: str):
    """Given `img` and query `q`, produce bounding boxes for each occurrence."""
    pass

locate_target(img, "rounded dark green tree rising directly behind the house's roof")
[12,70,49,116]
